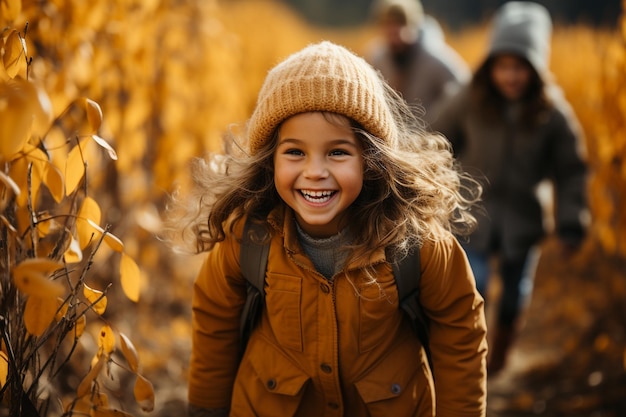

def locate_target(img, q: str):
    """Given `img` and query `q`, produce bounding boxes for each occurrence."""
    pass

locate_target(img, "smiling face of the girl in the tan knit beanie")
[274,112,363,237]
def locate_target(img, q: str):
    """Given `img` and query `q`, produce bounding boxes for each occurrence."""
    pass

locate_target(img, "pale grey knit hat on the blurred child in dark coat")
[487,1,552,76]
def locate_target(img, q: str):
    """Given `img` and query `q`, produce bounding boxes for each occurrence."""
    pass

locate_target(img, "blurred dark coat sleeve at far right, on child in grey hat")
[550,98,588,245]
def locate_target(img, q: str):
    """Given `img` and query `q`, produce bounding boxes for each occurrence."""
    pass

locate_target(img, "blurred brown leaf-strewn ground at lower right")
[487,236,626,417]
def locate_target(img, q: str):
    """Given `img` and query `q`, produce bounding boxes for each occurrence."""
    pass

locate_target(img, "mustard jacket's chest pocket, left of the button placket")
[265,273,302,352]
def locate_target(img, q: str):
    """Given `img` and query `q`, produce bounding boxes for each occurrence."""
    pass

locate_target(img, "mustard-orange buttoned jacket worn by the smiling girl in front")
[189,209,487,417]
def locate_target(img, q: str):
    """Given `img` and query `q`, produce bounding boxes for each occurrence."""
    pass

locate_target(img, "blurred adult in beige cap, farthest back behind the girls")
[366,0,471,122]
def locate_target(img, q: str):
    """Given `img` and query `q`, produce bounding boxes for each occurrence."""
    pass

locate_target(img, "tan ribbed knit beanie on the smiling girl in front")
[248,41,397,155]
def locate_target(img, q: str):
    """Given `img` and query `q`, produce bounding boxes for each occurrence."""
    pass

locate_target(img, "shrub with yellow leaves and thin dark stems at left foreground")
[0,22,154,416]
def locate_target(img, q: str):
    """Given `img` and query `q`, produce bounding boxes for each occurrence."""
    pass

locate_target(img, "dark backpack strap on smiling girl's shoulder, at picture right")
[391,248,434,375]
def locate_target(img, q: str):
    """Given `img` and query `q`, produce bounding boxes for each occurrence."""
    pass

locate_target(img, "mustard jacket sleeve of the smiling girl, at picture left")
[188,231,246,409]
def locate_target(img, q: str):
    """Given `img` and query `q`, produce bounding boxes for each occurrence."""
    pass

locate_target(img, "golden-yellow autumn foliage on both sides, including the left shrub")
[0,0,626,416]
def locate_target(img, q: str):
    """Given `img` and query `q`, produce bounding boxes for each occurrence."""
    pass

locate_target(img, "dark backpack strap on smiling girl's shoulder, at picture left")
[239,219,270,355]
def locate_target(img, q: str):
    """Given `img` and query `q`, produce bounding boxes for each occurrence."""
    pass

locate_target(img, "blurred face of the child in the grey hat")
[491,54,533,100]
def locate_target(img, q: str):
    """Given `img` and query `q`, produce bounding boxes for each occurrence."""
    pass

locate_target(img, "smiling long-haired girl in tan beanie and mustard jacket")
[169,42,486,417]
